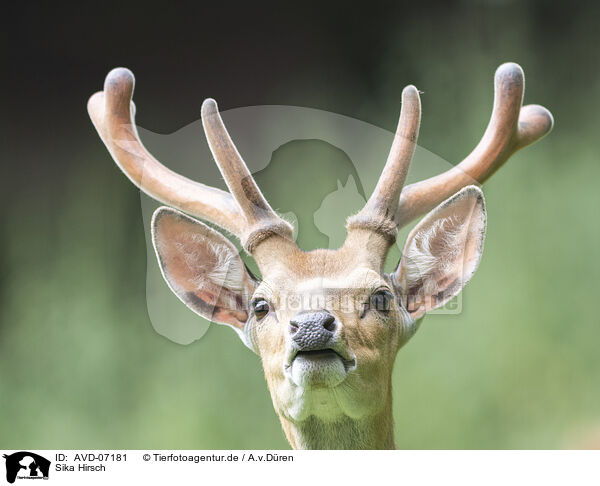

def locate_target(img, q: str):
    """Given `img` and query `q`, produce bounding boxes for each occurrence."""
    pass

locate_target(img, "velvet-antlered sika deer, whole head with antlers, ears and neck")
[88,63,553,448]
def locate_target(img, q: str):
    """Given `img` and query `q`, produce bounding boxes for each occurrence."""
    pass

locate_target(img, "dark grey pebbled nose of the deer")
[290,311,337,351]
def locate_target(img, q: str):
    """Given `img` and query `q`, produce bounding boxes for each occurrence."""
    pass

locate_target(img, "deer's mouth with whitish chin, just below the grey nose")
[284,348,356,388]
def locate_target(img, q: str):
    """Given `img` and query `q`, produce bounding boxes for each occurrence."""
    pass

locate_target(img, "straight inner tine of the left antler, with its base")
[202,98,293,251]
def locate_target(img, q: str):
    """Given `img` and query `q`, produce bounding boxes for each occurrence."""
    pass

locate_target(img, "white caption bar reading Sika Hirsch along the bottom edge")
[0,450,600,486]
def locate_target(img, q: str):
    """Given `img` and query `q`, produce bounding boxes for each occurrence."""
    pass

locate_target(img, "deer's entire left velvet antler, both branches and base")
[88,68,292,252]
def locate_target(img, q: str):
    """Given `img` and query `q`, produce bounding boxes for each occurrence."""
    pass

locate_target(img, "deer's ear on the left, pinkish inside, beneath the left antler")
[152,207,257,336]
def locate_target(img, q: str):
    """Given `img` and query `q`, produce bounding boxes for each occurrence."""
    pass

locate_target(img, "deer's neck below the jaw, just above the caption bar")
[280,390,396,449]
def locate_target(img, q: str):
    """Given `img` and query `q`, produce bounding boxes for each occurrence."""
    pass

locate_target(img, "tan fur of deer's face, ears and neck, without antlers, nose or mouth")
[152,186,485,449]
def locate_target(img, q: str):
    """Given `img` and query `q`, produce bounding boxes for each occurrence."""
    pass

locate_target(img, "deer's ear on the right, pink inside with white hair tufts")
[393,186,486,319]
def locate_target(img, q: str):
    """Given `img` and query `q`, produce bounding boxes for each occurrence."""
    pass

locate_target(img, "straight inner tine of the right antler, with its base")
[347,85,421,240]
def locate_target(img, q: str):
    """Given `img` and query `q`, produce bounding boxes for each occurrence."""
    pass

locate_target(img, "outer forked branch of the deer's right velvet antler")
[396,63,554,227]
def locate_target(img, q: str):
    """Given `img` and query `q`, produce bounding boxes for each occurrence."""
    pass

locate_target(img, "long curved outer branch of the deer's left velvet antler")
[88,68,246,236]
